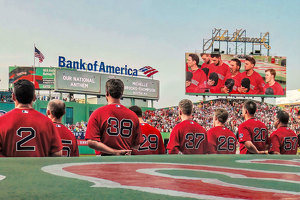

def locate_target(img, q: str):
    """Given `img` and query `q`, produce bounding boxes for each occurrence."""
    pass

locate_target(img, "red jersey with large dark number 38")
[85,104,143,155]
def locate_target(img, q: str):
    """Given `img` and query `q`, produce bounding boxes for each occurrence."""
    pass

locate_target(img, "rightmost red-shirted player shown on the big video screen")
[264,69,284,95]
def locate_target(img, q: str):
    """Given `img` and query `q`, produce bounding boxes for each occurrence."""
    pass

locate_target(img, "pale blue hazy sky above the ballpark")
[0,0,300,108]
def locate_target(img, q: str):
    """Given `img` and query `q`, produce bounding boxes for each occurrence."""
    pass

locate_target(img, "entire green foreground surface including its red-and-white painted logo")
[0,155,300,199]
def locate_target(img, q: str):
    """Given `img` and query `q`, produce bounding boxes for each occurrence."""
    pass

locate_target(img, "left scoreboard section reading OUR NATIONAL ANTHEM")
[55,69,101,95]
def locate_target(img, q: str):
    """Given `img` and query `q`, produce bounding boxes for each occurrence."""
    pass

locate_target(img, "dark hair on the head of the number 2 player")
[13,79,35,104]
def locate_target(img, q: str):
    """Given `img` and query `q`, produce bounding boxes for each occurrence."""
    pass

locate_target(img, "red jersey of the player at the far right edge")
[269,127,298,154]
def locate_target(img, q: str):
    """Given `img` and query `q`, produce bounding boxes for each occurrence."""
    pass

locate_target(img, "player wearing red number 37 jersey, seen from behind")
[167,99,207,154]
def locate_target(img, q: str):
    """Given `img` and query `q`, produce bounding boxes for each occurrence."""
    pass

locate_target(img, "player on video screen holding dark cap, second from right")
[238,56,265,94]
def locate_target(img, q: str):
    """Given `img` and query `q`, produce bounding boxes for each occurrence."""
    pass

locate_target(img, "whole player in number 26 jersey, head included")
[207,109,236,154]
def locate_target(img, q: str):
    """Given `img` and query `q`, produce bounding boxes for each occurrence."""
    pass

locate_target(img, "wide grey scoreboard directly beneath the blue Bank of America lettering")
[55,69,159,99]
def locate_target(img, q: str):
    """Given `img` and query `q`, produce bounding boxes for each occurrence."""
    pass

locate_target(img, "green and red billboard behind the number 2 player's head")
[9,66,55,90]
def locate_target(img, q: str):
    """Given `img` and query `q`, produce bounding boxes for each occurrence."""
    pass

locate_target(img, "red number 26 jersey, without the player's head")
[207,126,236,154]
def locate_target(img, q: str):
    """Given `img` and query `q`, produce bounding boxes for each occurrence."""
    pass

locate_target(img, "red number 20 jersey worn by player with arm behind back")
[238,118,268,154]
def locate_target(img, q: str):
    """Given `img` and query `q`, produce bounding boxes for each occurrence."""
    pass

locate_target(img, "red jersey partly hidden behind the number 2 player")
[54,123,79,157]
